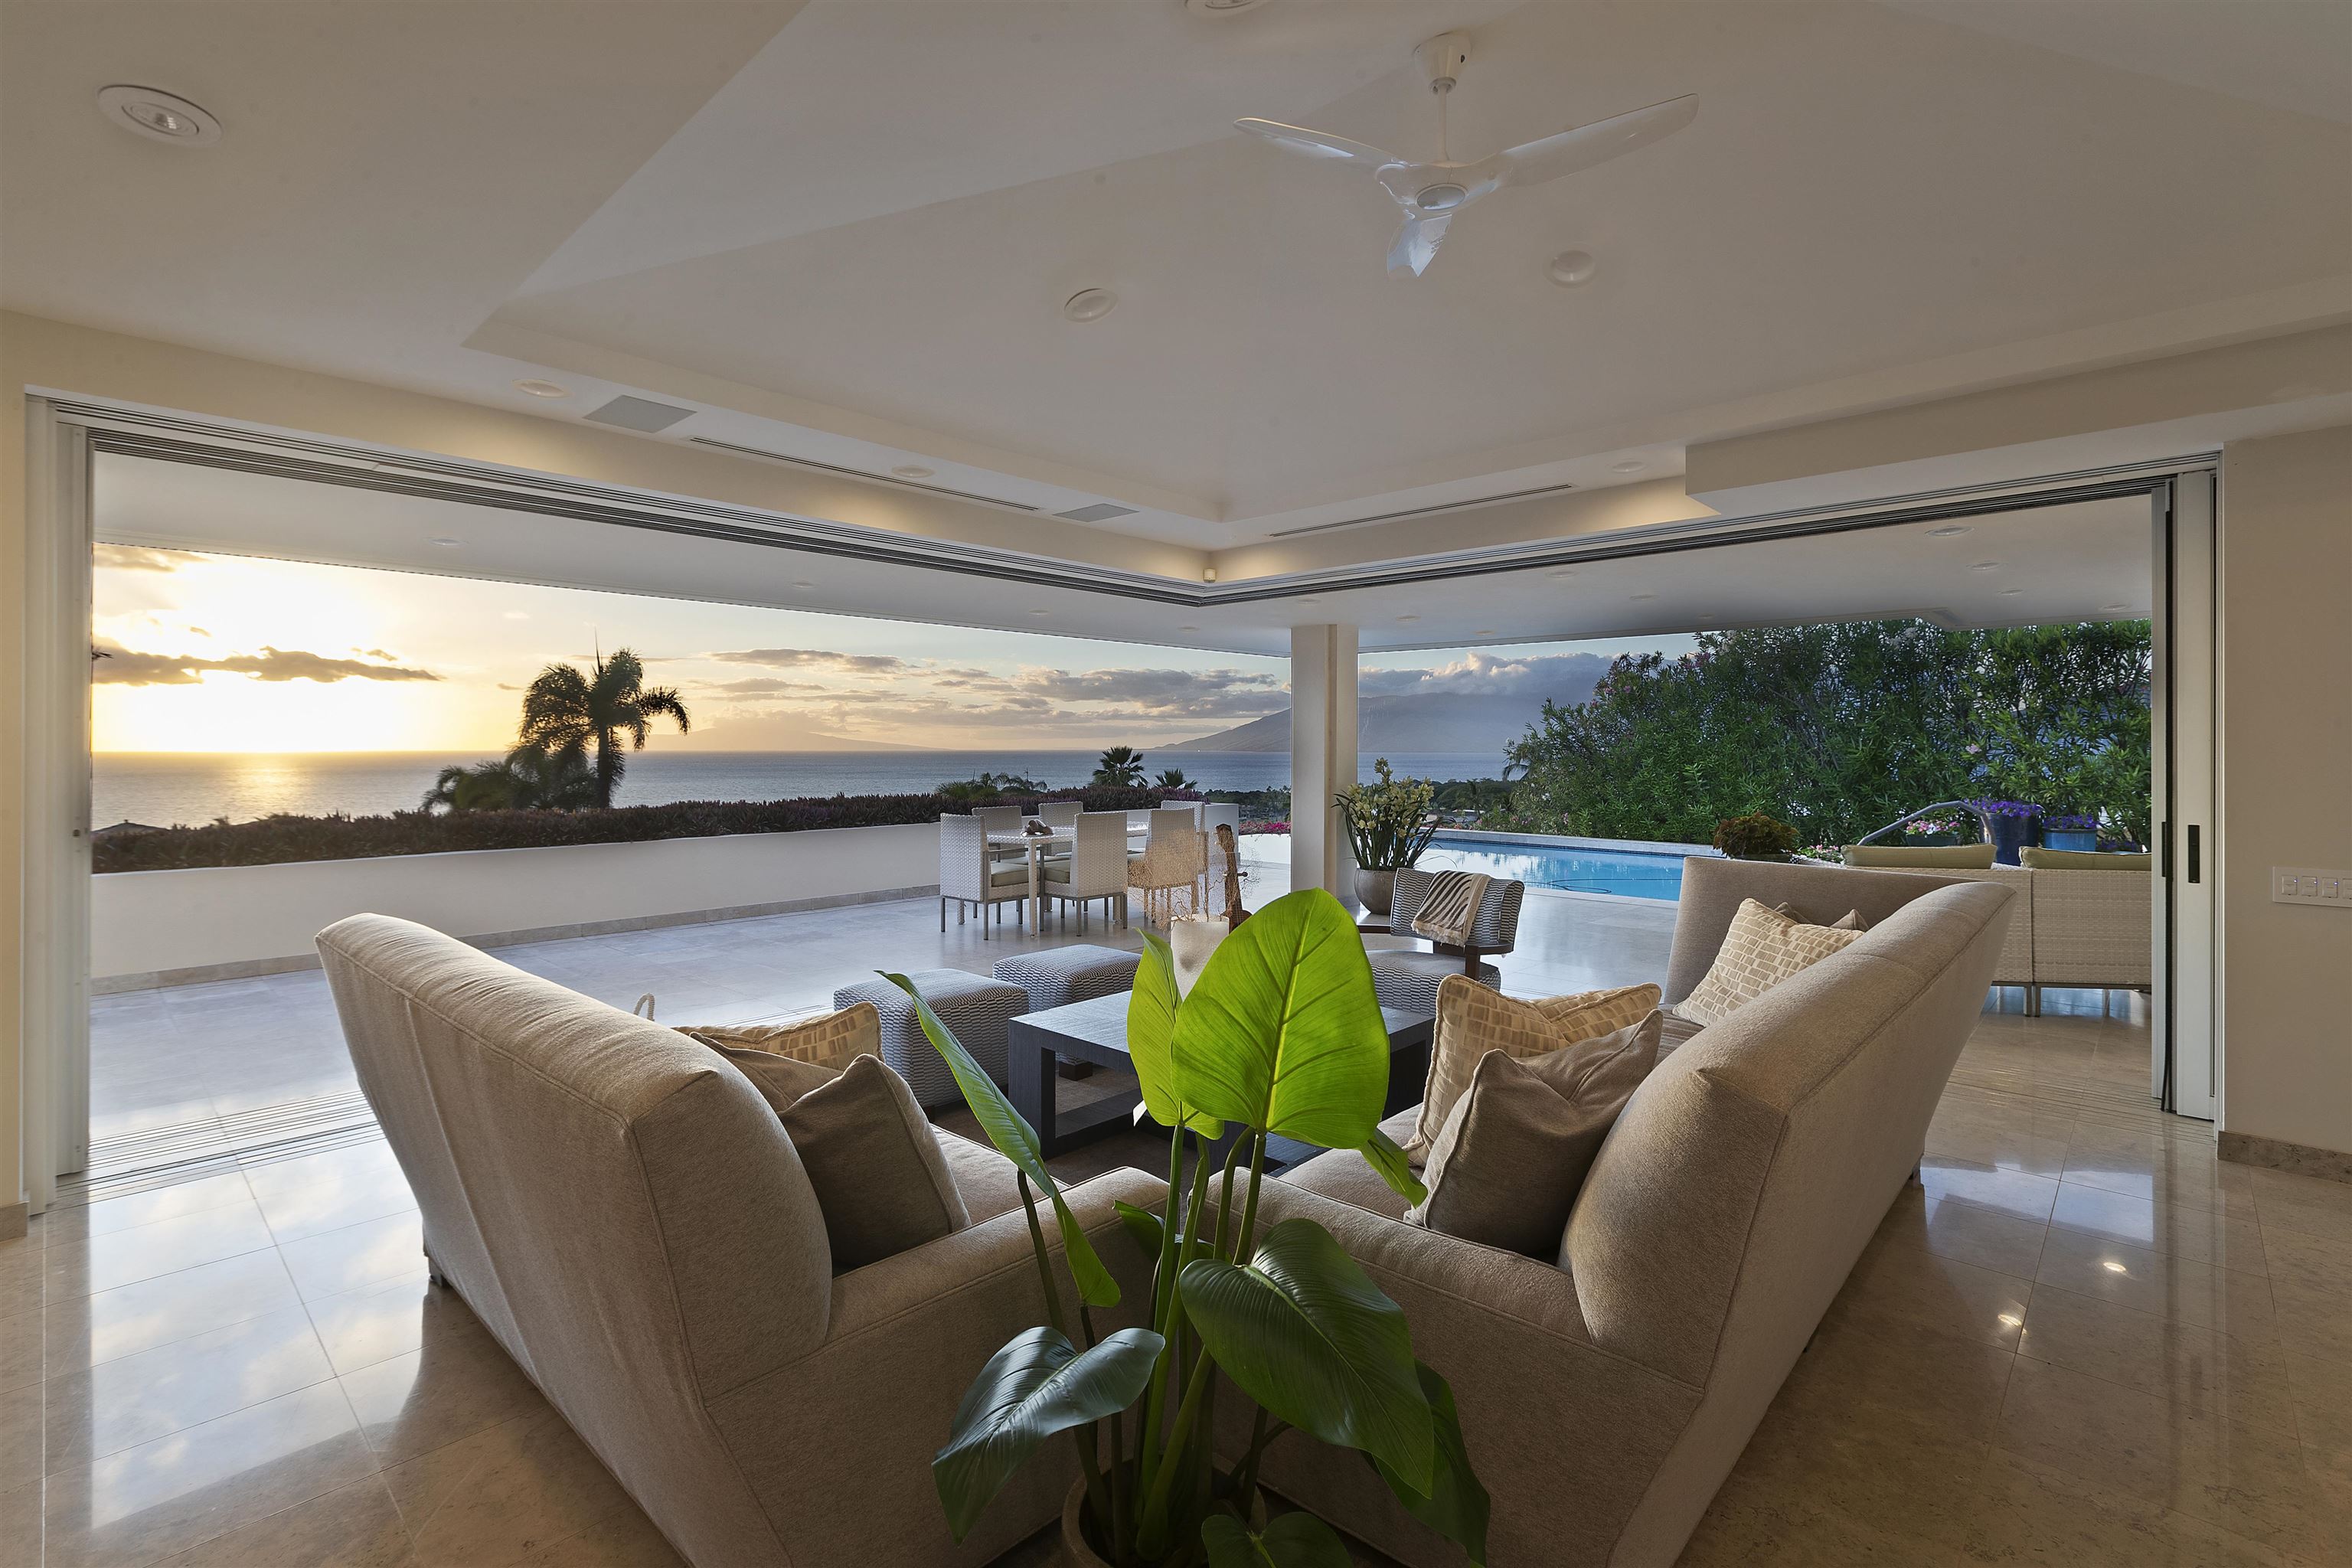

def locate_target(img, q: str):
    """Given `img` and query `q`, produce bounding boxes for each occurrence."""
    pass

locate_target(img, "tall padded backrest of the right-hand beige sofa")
[1560,884,2014,1382]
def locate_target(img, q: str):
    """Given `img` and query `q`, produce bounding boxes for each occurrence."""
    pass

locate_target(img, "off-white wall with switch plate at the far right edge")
[2218,426,2352,1152]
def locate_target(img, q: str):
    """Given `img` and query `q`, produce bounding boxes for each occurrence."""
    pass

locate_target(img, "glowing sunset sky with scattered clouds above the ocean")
[94,545,1689,753]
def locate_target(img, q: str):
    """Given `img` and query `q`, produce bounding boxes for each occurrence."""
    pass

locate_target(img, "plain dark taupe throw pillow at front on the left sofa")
[783,1056,972,1274]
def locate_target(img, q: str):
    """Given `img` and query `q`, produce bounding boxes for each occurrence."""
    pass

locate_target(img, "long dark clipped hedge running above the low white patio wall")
[92,788,1197,872]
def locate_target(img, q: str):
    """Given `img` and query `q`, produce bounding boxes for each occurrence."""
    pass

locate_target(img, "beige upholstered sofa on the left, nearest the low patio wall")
[318,914,1165,1568]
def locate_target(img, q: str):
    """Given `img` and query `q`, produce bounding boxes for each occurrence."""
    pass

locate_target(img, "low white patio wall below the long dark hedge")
[90,823,939,992]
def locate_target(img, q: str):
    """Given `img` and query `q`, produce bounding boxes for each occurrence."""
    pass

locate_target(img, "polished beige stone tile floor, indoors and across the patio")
[28,874,2352,1568]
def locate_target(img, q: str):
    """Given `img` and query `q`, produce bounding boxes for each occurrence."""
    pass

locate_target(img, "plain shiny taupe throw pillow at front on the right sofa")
[1404,1011,1663,1260]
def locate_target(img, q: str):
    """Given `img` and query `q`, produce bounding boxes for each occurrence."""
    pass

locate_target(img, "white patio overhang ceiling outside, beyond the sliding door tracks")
[94,454,2150,656]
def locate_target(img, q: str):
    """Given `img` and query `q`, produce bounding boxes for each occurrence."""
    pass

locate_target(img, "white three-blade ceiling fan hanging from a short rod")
[1235,33,1698,277]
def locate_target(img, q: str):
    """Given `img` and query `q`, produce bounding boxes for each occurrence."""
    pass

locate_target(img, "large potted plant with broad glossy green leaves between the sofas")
[889,889,1489,1568]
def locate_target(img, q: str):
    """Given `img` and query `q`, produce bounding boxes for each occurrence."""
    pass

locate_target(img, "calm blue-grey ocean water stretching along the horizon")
[90,750,1503,828]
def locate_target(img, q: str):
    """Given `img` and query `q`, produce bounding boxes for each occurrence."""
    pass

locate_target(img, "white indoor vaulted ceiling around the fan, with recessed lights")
[0,0,2352,571]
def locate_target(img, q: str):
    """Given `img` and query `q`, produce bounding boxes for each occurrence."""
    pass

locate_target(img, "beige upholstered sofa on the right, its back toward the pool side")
[1220,861,2018,1568]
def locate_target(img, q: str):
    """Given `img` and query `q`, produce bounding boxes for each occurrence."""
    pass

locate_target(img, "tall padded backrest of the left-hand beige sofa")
[318,914,832,1561]
